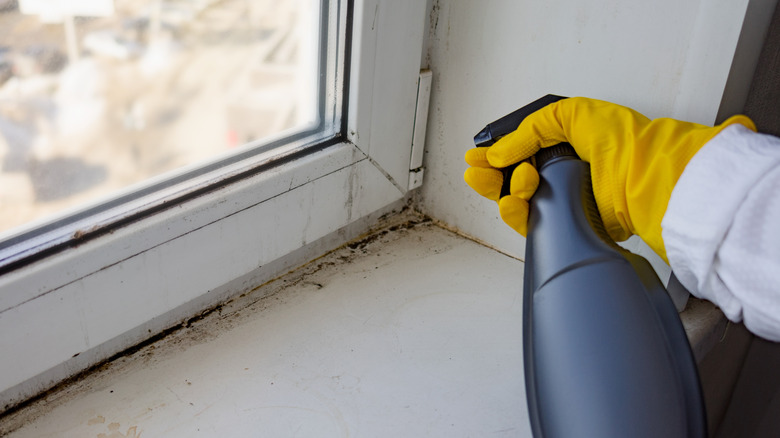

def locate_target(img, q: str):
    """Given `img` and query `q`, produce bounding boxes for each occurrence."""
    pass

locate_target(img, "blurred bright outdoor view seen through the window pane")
[0,0,319,234]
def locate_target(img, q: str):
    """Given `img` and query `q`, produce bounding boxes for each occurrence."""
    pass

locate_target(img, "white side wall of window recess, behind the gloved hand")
[421,0,757,258]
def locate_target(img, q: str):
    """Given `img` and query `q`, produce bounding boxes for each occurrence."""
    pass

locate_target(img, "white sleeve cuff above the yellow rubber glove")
[661,125,780,341]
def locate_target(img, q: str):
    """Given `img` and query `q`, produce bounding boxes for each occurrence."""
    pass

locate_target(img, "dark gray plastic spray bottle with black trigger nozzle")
[474,95,707,438]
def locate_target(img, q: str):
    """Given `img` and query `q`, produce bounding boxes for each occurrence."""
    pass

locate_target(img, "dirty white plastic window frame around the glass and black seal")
[0,0,426,411]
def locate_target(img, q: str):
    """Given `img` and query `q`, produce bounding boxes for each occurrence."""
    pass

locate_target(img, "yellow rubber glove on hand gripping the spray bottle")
[464,97,756,260]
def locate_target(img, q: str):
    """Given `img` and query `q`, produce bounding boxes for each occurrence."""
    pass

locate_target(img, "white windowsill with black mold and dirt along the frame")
[0,210,725,438]
